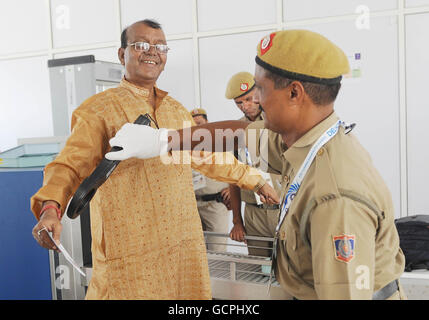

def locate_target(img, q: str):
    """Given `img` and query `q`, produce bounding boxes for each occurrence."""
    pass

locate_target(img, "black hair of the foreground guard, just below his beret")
[265,69,341,106]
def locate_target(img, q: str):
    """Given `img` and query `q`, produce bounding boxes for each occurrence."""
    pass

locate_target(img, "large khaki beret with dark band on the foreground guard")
[255,30,350,84]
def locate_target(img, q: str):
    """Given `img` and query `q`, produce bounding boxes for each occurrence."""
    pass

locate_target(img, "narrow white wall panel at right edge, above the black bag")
[405,13,429,218]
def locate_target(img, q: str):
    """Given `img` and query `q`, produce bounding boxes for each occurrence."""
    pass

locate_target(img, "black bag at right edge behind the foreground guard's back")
[395,215,429,272]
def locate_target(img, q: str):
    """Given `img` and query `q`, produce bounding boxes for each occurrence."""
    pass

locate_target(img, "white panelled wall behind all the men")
[0,0,429,217]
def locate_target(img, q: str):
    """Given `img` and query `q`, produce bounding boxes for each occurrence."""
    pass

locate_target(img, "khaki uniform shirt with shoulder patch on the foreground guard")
[249,113,405,299]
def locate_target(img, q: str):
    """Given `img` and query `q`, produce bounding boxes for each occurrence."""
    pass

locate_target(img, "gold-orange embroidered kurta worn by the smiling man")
[31,80,263,299]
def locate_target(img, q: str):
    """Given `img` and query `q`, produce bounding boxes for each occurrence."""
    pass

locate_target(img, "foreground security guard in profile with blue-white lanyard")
[247,30,405,299]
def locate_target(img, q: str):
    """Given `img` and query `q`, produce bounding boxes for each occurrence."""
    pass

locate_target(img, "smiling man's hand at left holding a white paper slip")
[33,209,63,251]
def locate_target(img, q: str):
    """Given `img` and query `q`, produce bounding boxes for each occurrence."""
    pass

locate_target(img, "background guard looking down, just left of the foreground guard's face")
[225,72,281,257]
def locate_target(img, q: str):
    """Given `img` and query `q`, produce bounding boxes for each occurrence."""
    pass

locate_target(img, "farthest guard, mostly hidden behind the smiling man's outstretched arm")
[191,108,230,251]
